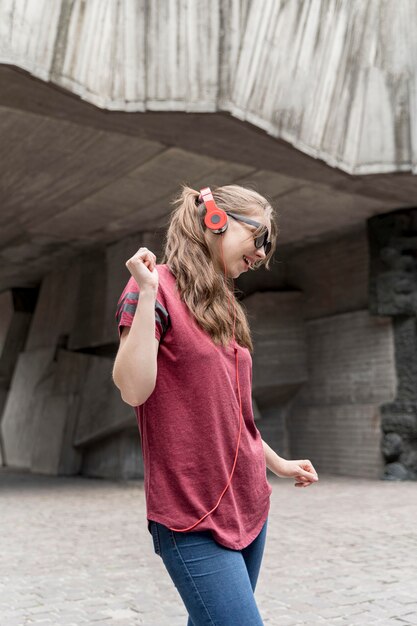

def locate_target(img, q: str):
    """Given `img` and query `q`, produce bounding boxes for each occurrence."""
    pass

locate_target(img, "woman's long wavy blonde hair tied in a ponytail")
[162,185,278,352]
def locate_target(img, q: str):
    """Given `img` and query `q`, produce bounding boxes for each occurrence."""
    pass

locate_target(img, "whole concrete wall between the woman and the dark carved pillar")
[240,226,397,478]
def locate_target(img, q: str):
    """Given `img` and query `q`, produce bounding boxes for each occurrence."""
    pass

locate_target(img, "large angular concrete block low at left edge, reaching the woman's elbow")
[2,348,136,474]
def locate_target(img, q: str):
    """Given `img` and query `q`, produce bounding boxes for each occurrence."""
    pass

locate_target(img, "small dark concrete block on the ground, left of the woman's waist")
[81,428,144,479]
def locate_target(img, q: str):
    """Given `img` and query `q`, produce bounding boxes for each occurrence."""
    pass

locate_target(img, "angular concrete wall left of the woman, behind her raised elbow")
[0,233,161,478]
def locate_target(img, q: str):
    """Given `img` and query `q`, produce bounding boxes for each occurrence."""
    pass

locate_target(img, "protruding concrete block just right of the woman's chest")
[243,292,307,412]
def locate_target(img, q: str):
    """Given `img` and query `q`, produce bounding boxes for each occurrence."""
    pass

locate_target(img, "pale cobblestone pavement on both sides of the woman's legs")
[0,469,417,626]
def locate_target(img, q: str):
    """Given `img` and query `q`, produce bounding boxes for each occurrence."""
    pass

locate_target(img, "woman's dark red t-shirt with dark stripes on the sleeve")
[116,265,272,550]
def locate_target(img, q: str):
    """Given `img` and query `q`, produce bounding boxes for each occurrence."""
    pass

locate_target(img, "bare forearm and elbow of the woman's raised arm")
[113,290,159,406]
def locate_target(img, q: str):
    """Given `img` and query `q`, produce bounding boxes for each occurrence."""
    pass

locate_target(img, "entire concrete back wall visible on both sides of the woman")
[1,223,396,478]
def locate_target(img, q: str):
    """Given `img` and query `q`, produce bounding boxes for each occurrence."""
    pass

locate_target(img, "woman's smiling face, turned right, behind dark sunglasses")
[206,208,271,278]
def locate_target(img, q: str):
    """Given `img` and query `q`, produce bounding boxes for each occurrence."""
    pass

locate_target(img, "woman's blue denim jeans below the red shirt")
[150,520,268,626]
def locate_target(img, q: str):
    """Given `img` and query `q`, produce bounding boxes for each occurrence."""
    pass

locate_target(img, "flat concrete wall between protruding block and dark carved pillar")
[286,231,397,478]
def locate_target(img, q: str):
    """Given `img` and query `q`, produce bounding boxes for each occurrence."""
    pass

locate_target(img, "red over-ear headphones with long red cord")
[170,187,243,532]
